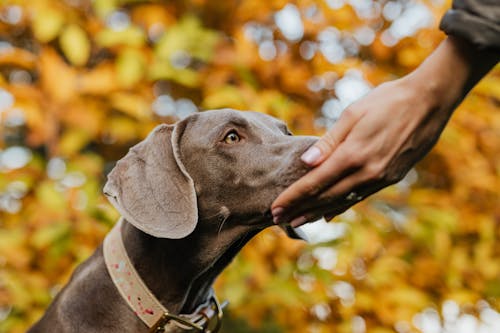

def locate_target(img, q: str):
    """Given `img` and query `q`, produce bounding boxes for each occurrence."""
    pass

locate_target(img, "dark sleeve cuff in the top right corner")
[439,0,500,52]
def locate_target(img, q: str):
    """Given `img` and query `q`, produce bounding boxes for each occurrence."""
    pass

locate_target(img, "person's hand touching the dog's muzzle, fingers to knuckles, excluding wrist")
[272,78,450,227]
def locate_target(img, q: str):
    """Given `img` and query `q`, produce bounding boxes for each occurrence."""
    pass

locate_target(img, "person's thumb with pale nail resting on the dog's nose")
[301,110,359,167]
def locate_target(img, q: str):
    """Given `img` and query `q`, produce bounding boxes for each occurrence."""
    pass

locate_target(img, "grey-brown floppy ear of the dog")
[104,125,198,238]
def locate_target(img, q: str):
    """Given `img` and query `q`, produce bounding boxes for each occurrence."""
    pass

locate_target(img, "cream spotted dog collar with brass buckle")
[103,218,225,333]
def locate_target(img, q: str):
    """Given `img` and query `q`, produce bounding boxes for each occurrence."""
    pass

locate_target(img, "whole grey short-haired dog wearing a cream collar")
[29,109,316,333]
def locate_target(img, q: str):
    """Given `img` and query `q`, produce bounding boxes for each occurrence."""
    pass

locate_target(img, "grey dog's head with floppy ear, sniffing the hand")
[104,109,316,239]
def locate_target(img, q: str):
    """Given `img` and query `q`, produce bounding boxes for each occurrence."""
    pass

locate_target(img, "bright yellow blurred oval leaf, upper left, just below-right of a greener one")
[59,24,90,66]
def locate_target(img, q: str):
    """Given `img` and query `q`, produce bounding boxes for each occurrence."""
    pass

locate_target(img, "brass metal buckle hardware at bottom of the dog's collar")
[149,296,228,333]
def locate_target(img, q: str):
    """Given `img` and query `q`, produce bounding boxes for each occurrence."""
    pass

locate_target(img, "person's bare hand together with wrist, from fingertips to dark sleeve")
[271,36,499,227]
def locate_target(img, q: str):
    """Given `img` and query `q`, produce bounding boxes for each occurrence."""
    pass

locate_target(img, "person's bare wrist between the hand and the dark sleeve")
[404,36,499,116]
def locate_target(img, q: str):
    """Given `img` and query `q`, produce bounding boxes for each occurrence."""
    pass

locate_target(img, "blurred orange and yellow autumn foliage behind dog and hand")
[0,0,500,333]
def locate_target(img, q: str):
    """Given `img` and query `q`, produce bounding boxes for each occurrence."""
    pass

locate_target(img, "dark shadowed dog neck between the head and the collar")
[122,215,260,314]
